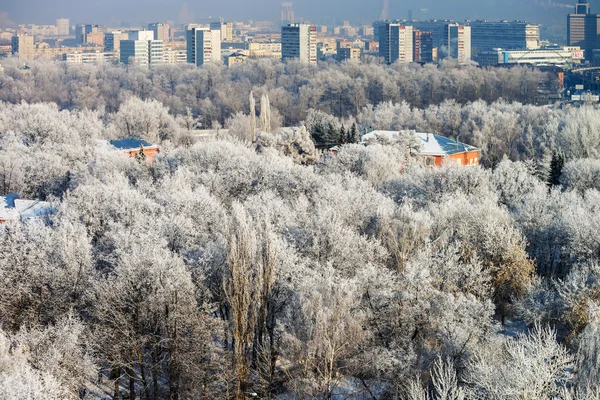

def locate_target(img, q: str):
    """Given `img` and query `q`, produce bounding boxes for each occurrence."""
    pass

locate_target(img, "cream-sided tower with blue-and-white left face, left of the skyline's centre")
[186,27,222,67]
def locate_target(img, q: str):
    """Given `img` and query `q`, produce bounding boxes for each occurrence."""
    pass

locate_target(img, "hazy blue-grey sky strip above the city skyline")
[0,0,584,25]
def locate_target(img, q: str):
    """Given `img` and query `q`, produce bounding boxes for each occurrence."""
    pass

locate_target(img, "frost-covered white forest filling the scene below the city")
[0,59,600,400]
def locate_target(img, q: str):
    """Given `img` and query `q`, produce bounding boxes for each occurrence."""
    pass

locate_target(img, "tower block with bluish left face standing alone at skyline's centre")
[281,24,317,64]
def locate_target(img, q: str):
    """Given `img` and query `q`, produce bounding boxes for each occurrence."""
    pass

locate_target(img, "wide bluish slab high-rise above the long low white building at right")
[469,21,540,55]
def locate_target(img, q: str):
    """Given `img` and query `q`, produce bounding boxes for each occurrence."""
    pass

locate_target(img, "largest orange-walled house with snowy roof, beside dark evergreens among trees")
[362,131,479,167]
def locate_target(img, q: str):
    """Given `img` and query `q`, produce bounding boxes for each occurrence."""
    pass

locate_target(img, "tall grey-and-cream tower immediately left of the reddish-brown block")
[379,22,414,64]
